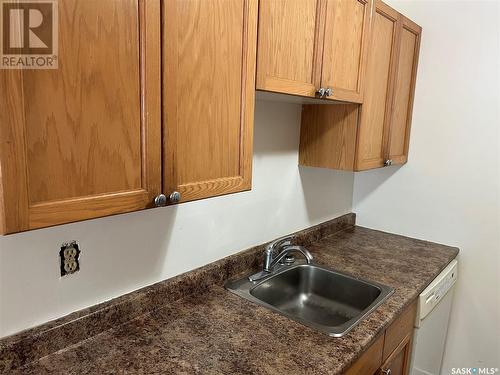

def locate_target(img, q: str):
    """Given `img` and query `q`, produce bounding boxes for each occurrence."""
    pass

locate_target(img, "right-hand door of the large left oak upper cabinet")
[163,0,257,201]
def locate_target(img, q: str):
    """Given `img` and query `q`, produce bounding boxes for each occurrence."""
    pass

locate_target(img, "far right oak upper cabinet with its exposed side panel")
[299,0,422,171]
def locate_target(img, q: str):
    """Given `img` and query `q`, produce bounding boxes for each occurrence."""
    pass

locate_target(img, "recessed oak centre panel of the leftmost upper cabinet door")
[24,0,141,203]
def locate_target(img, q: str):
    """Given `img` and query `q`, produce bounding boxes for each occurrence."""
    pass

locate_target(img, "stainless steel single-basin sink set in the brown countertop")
[226,264,393,337]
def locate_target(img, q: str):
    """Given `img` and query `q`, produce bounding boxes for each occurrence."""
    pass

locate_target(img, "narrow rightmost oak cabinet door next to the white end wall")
[388,15,422,164]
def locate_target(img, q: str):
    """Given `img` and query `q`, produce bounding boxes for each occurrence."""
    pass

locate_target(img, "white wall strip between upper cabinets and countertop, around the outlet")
[0,102,354,337]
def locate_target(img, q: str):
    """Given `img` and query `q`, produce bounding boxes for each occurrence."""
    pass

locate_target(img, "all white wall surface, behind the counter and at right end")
[0,4,500,374]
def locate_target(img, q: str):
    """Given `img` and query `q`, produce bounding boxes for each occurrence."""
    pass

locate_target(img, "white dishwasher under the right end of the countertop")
[411,259,458,375]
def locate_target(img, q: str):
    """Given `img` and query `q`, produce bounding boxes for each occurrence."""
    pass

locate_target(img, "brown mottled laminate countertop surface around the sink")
[12,227,458,375]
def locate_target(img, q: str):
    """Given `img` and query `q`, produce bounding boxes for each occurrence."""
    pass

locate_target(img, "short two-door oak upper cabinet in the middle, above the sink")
[257,0,371,103]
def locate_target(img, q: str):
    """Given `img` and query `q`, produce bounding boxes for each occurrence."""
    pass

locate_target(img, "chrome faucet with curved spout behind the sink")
[248,236,313,281]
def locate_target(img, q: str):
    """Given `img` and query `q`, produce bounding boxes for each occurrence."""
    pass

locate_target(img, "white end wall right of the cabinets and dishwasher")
[353,0,500,374]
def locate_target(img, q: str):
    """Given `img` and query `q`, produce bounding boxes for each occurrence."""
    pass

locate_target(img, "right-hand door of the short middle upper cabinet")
[321,0,371,103]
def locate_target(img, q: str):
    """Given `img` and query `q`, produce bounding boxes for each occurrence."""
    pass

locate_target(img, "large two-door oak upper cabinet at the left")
[0,0,258,234]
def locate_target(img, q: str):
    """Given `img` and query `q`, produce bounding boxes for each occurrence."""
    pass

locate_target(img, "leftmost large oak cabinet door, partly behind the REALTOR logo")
[0,0,161,233]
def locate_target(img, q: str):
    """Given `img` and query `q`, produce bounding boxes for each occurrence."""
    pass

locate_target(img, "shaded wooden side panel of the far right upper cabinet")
[299,104,359,171]
